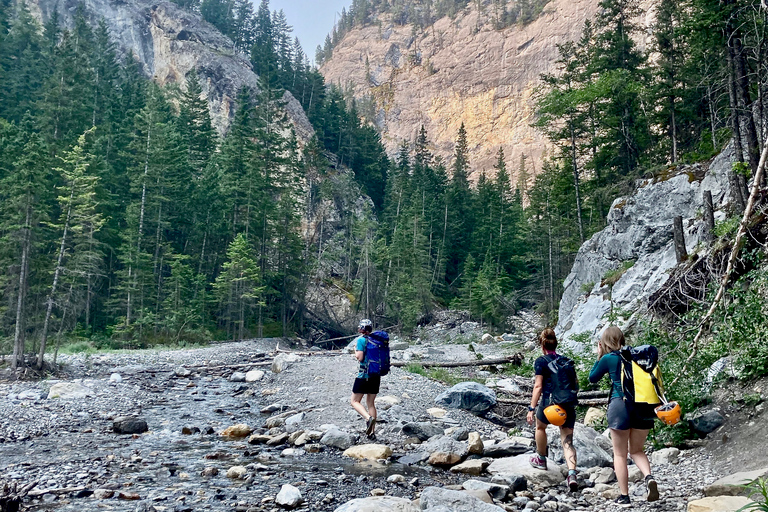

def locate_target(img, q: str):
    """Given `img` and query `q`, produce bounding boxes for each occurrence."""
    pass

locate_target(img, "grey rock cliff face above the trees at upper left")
[25,0,313,140]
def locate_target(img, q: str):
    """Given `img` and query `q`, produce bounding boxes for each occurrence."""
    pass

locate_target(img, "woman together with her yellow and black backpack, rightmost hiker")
[589,326,664,508]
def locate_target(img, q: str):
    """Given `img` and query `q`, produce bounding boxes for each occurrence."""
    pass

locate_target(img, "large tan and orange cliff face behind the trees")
[320,0,656,179]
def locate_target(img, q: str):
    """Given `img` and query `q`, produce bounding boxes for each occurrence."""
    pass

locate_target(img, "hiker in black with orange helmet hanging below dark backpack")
[527,328,579,492]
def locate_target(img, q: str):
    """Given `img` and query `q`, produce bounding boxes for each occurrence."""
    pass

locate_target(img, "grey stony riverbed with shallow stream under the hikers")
[0,340,760,512]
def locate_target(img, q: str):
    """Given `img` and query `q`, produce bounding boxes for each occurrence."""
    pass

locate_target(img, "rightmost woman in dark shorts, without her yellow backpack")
[589,326,659,507]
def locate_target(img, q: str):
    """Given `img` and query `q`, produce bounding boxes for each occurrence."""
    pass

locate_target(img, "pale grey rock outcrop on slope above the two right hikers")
[556,147,735,349]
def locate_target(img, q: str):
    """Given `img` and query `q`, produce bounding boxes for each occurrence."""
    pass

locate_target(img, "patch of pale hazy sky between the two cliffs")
[270,0,352,59]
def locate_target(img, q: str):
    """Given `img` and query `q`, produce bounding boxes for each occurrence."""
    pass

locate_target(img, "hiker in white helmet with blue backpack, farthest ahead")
[350,318,390,438]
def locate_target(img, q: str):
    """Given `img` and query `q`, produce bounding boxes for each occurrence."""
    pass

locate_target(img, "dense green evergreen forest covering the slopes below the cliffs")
[0,0,768,372]
